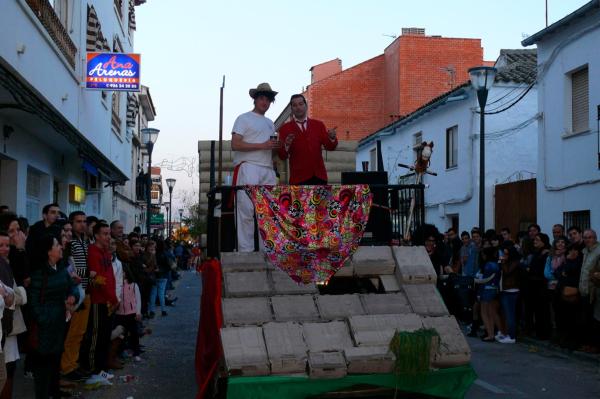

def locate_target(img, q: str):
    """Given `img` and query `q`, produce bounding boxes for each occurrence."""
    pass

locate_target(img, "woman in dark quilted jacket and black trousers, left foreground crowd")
[29,235,79,399]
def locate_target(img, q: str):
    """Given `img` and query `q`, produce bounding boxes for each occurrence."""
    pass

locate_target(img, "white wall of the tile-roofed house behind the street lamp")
[356,84,537,234]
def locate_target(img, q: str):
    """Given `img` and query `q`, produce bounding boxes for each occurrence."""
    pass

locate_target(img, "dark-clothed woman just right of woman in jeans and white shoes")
[524,233,551,340]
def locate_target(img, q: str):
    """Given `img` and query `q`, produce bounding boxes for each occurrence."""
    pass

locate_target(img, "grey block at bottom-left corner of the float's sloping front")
[221,327,269,376]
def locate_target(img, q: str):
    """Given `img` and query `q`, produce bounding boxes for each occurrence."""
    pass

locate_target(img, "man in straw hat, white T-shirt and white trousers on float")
[231,83,279,252]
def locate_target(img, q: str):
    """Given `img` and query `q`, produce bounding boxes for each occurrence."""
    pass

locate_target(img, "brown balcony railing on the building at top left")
[26,0,77,68]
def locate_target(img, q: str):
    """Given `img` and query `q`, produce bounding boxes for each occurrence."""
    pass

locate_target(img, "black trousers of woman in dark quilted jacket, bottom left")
[27,352,61,399]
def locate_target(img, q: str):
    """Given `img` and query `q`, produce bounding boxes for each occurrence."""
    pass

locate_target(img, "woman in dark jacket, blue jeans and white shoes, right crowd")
[496,241,521,344]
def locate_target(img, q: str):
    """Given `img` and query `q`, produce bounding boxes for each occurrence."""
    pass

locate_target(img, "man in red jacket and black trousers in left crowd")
[82,222,119,374]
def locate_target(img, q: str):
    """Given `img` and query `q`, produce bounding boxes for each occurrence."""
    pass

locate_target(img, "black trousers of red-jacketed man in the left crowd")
[79,303,112,374]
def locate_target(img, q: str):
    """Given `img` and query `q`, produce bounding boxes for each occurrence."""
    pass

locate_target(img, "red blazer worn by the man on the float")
[278,118,338,184]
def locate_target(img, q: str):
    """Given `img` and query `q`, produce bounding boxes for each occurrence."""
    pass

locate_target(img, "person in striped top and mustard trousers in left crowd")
[60,211,91,381]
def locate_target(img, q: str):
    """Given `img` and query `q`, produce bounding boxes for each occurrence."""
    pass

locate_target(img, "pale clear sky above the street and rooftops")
[134,0,588,216]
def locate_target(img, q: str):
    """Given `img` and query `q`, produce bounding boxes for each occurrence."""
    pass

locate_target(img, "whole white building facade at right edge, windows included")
[523,0,600,231]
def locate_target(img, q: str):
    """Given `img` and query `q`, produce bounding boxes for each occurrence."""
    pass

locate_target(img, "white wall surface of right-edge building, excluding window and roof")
[537,12,600,231]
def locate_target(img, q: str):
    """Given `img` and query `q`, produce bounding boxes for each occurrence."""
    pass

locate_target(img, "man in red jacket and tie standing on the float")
[278,94,338,185]
